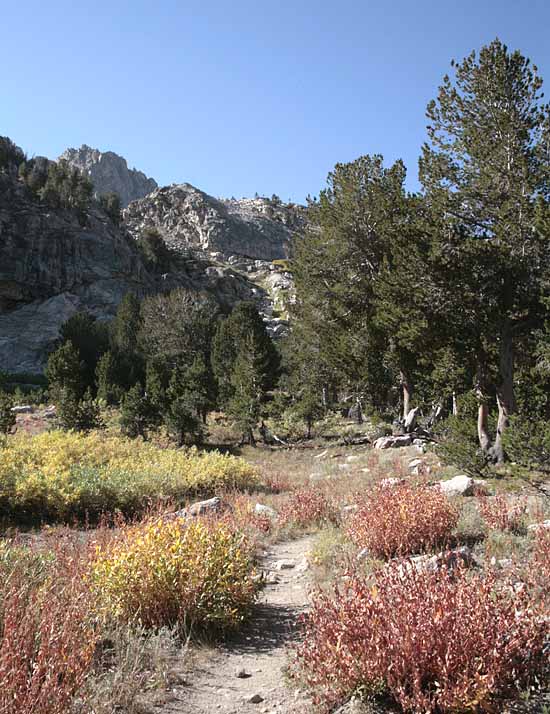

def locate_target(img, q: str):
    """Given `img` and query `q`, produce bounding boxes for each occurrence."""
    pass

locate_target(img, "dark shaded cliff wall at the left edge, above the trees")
[0,174,153,372]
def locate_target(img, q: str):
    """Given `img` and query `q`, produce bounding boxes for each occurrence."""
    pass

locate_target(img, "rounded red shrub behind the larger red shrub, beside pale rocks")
[347,483,459,558]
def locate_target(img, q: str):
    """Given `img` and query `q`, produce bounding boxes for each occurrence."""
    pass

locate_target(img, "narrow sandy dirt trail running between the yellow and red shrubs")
[162,536,314,714]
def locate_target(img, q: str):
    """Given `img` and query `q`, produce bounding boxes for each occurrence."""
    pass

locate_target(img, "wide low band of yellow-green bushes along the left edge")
[0,431,257,521]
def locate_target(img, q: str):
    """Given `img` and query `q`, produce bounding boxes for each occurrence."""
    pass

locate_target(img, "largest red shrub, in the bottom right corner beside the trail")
[294,567,547,714]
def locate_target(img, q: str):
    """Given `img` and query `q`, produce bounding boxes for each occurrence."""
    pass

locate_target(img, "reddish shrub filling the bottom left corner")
[0,544,96,714]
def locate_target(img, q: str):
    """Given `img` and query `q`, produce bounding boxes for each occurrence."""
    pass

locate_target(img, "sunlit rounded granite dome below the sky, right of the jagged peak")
[124,183,305,261]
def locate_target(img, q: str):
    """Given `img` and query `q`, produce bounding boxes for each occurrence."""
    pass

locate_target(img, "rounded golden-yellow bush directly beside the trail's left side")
[91,518,257,629]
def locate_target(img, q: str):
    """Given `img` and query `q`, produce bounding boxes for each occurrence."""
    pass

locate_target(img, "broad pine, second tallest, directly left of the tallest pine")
[292,155,414,414]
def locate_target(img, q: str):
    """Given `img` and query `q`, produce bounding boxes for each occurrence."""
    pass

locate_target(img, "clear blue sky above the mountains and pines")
[4,0,550,201]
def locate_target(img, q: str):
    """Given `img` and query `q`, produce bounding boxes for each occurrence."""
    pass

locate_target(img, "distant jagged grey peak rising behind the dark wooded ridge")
[59,144,157,208]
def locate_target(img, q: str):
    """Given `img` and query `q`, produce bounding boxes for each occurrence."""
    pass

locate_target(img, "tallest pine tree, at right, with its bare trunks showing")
[420,39,550,462]
